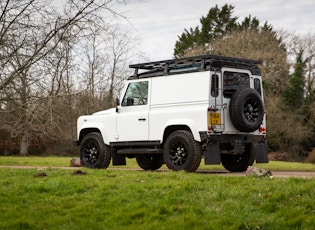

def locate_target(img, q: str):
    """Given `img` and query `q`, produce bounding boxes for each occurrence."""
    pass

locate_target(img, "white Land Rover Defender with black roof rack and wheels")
[74,55,268,172]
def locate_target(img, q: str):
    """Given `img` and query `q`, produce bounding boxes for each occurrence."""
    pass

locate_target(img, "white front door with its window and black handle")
[116,80,150,142]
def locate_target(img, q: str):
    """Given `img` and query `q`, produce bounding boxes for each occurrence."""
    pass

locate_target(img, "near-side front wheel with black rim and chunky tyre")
[80,132,111,168]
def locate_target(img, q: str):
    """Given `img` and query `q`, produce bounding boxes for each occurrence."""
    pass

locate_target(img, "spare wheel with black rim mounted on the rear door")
[229,88,264,132]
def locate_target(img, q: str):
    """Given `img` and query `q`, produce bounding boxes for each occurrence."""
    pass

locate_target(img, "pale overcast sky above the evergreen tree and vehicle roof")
[115,0,315,61]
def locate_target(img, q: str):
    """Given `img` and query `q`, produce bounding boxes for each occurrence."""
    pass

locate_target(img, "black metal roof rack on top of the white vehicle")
[129,55,262,78]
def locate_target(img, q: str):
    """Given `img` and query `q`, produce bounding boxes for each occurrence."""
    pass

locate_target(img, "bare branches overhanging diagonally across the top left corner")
[0,0,123,90]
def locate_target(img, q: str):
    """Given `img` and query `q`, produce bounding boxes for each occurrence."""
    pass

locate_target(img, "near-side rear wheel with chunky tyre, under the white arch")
[163,130,202,172]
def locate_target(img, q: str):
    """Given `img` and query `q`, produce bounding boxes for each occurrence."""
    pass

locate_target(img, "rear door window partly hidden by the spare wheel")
[223,71,250,98]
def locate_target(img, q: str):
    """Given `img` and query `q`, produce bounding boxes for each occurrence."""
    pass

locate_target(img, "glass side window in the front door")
[121,81,149,106]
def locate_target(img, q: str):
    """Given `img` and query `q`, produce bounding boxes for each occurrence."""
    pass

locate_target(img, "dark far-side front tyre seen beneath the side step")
[136,154,164,171]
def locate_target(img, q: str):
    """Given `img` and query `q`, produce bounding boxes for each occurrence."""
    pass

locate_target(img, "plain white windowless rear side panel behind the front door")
[149,71,210,141]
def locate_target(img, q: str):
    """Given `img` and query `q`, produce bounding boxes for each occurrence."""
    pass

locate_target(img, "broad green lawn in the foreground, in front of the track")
[0,168,315,230]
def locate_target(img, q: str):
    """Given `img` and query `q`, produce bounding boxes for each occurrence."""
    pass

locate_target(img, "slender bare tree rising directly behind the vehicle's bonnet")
[75,25,140,114]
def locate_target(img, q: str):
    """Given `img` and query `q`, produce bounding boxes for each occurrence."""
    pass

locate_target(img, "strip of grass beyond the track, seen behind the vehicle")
[0,156,315,171]
